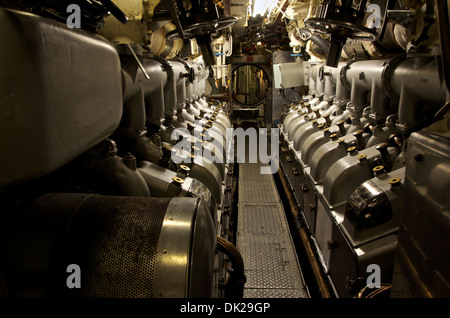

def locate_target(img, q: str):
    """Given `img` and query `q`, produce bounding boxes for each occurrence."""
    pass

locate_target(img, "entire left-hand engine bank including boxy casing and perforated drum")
[0,1,244,298]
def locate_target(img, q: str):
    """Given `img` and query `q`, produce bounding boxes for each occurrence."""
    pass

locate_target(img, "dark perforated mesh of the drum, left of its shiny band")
[59,196,171,298]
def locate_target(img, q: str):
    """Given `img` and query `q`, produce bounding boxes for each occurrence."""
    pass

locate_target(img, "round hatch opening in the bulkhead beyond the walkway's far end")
[232,64,270,107]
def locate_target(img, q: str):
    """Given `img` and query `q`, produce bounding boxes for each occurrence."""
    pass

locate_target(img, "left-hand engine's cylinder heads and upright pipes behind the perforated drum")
[86,45,231,230]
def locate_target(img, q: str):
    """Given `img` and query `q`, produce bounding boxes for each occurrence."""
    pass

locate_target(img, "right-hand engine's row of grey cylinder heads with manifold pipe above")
[280,56,448,296]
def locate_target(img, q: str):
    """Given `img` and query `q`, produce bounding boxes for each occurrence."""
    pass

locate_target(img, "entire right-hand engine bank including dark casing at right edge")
[280,0,450,297]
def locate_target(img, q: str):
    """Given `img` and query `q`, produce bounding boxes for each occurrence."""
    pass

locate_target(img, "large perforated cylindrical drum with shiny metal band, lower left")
[3,194,216,298]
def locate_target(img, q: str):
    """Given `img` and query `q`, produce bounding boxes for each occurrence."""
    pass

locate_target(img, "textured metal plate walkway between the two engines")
[236,163,308,298]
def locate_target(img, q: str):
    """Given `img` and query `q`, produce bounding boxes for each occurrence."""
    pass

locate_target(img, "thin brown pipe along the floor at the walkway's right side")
[278,168,332,298]
